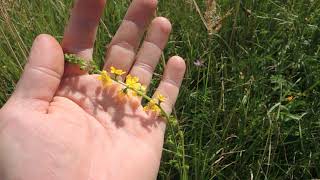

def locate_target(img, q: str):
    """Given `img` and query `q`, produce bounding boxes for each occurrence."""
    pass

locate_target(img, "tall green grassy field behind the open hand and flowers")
[0,0,320,180]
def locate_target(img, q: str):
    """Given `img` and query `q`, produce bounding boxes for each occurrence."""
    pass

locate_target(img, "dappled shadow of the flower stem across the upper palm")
[56,75,164,132]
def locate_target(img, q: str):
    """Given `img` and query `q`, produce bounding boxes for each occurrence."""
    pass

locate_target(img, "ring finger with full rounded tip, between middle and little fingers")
[130,17,171,87]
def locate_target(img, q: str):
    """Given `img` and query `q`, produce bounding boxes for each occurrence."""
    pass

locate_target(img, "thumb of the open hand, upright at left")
[14,34,64,102]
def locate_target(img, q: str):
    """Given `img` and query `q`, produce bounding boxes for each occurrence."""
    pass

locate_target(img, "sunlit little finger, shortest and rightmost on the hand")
[154,56,186,114]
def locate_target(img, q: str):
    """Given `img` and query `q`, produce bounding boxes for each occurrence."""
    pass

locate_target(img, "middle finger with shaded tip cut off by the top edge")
[104,0,157,72]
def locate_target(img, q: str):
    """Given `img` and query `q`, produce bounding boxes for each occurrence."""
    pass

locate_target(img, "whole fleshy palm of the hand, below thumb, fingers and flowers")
[1,75,164,179]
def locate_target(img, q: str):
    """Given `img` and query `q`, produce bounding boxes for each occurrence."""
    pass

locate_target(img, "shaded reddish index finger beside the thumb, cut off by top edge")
[62,0,106,74]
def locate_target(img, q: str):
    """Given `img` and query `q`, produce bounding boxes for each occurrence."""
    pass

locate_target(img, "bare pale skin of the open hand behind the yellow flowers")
[0,0,185,180]
